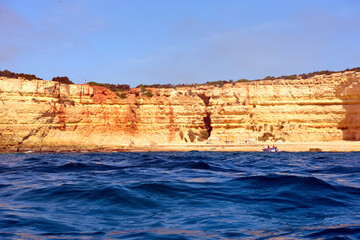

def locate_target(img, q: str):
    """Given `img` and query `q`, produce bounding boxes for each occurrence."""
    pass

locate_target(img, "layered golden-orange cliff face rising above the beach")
[0,71,360,152]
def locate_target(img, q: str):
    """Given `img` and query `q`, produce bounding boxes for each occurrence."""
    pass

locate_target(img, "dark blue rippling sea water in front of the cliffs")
[0,152,360,239]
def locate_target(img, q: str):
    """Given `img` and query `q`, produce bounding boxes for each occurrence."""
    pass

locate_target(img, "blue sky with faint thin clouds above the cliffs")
[0,0,360,87]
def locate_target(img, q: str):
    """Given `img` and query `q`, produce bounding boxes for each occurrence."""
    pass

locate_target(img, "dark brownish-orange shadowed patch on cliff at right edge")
[336,72,360,141]
